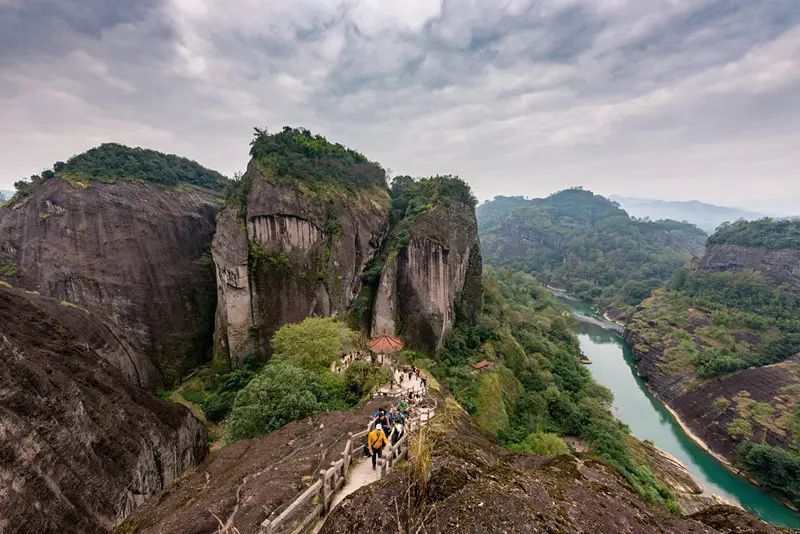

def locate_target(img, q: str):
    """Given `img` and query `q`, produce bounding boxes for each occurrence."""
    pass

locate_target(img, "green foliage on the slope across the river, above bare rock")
[627,268,800,379]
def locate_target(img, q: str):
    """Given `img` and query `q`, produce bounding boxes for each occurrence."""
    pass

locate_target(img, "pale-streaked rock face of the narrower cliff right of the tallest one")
[372,201,482,352]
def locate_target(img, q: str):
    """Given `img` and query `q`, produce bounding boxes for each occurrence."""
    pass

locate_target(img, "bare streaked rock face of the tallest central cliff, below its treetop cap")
[214,160,389,362]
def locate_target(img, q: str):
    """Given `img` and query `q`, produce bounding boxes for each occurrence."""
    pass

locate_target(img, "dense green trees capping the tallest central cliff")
[250,126,386,195]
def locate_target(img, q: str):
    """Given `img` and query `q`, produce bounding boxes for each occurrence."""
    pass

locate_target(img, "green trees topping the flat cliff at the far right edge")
[708,217,800,249]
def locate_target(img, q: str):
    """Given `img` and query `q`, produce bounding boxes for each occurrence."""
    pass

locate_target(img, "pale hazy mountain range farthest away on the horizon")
[608,195,766,234]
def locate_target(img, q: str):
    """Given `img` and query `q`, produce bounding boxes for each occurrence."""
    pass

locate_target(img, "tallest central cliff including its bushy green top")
[213,130,389,363]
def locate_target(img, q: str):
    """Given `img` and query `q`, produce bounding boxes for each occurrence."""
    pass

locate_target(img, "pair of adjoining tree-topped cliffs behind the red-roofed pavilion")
[212,128,481,364]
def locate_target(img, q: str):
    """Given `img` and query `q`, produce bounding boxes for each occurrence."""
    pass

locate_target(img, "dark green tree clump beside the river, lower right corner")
[737,441,800,506]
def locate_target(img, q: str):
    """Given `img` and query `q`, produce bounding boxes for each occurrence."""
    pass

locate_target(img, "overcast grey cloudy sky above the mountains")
[0,0,800,214]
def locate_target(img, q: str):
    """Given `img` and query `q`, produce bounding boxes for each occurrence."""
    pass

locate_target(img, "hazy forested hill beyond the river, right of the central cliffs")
[477,188,706,315]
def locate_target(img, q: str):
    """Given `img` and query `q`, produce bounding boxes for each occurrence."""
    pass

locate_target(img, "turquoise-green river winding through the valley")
[566,300,800,529]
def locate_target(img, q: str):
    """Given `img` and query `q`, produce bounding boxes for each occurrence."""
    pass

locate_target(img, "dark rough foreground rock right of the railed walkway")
[320,404,782,534]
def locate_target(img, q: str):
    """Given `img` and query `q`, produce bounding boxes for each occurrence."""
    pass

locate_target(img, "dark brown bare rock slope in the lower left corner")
[0,287,206,533]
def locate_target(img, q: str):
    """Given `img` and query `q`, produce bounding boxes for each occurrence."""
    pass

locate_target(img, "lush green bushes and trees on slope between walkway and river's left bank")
[430,268,675,508]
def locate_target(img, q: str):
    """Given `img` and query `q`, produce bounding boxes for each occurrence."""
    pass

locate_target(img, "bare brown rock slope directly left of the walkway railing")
[124,401,386,534]
